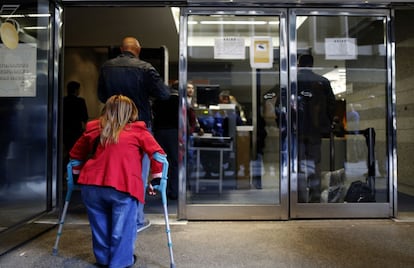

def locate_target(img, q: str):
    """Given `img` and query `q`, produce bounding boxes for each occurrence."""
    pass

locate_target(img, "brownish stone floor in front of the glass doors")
[0,219,414,268]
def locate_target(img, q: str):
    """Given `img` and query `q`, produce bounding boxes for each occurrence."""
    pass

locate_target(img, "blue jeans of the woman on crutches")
[81,185,139,268]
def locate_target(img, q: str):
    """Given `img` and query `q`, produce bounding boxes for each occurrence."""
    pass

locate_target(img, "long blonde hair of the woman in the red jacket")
[100,95,138,146]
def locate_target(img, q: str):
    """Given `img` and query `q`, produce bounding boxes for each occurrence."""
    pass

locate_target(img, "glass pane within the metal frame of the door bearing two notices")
[187,14,280,204]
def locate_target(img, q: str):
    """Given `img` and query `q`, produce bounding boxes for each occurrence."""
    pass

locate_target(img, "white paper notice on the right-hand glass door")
[325,38,358,60]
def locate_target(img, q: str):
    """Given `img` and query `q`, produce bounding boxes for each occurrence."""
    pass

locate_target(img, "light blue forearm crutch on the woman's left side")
[52,159,82,256]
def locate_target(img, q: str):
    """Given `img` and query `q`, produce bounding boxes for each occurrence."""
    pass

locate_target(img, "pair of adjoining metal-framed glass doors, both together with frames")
[178,8,396,220]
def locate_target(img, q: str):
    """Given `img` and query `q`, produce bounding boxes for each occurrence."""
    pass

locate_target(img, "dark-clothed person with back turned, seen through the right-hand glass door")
[296,55,336,203]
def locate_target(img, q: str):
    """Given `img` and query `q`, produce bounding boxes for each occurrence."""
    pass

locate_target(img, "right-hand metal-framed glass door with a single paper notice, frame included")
[288,9,395,218]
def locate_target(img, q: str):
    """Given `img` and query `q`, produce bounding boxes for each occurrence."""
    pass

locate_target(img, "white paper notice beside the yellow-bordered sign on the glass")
[214,37,246,60]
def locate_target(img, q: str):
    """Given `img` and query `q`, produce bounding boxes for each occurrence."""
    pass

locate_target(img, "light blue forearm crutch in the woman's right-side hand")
[153,153,175,268]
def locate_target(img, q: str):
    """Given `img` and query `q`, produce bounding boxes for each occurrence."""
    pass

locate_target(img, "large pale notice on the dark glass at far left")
[0,44,37,97]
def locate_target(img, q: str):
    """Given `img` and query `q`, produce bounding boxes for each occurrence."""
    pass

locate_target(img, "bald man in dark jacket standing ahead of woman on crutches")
[98,37,170,232]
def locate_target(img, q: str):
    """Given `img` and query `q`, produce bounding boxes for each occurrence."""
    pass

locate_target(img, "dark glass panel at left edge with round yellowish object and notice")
[0,0,51,231]
